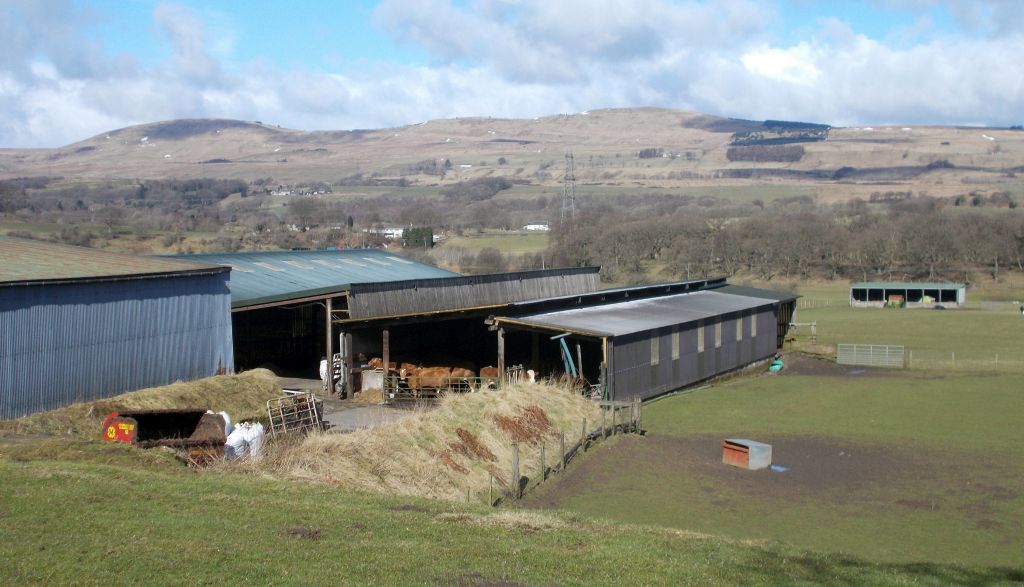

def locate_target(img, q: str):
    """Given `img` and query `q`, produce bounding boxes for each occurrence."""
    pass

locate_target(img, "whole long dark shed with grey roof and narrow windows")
[493,280,796,400]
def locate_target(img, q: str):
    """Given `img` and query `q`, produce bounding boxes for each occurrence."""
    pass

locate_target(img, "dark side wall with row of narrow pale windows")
[611,306,776,400]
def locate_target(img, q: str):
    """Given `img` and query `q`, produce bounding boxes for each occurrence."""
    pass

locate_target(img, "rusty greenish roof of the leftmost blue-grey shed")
[0,237,221,285]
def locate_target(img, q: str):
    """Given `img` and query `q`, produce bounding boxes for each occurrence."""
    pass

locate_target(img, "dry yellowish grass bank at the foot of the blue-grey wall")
[0,369,281,438]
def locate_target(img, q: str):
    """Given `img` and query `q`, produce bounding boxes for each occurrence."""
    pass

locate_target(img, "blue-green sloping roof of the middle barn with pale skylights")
[173,249,459,308]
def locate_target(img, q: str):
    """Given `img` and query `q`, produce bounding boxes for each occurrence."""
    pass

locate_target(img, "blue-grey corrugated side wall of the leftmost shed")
[0,272,234,419]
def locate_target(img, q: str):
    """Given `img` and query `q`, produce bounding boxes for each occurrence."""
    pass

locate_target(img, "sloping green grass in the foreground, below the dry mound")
[0,447,1020,585]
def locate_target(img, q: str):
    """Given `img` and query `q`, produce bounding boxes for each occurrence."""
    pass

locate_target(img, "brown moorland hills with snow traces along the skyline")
[0,109,1024,200]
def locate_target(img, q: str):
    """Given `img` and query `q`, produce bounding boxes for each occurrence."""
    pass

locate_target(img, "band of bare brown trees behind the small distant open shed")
[551,199,1024,283]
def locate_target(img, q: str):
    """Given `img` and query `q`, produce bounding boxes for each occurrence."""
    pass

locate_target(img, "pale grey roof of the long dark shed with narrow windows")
[499,291,773,336]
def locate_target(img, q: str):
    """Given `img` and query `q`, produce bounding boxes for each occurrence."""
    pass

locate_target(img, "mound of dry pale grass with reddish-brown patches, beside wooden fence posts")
[266,383,600,502]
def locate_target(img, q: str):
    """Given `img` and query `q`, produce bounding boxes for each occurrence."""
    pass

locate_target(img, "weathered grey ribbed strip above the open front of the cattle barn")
[348,267,600,320]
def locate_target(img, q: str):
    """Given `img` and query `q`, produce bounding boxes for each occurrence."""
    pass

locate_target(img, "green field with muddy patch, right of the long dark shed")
[528,280,1024,569]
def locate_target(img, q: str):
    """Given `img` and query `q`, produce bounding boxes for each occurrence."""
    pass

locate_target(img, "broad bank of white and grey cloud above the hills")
[0,0,1024,146]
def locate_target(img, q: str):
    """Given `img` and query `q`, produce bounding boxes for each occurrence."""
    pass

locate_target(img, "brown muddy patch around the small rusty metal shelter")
[523,434,1024,529]
